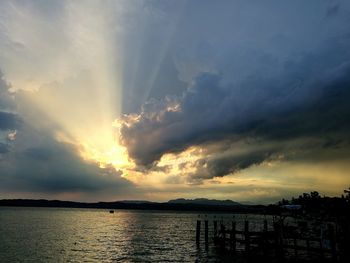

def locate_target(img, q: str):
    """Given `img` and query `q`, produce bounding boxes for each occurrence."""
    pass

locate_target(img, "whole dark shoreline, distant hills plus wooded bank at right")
[0,188,350,219]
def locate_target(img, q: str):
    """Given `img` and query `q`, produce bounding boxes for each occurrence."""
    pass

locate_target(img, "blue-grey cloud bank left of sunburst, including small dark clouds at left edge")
[0,71,133,198]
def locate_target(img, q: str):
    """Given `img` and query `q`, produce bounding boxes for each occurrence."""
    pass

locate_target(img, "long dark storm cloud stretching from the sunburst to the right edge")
[122,61,350,168]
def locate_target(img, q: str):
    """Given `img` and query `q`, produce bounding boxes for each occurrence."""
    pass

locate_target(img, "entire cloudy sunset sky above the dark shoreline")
[0,0,350,204]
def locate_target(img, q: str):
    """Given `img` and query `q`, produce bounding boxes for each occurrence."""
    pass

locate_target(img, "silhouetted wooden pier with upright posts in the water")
[196,219,339,262]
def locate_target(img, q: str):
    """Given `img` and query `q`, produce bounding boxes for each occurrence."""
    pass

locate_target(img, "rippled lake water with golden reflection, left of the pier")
[0,207,270,263]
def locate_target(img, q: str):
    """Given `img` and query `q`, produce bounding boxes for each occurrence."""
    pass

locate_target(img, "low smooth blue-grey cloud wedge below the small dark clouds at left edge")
[0,126,132,193]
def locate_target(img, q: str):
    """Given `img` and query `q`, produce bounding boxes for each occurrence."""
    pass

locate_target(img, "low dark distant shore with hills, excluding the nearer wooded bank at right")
[0,199,266,213]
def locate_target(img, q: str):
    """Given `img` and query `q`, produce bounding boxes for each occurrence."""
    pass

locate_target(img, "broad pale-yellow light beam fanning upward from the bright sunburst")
[8,1,133,169]
